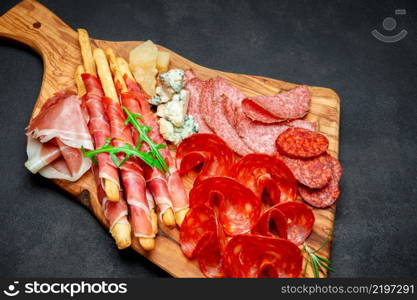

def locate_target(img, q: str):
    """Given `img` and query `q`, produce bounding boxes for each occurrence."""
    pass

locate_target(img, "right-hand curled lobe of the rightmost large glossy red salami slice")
[274,201,315,246]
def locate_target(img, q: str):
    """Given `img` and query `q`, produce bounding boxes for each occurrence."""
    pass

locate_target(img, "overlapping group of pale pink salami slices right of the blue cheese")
[185,71,317,155]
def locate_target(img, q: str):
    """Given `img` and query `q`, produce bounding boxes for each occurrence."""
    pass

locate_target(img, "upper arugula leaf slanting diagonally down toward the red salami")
[123,106,168,172]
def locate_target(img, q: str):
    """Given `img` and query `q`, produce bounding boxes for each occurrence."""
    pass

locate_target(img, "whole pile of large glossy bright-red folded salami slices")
[177,134,315,278]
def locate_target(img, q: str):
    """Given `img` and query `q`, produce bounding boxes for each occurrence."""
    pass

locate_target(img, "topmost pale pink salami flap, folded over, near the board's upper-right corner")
[247,86,311,119]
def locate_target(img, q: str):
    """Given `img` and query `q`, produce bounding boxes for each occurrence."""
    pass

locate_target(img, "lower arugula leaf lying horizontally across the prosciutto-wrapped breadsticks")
[81,138,161,168]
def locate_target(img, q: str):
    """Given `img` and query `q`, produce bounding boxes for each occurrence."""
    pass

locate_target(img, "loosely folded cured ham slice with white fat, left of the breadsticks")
[25,91,93,181]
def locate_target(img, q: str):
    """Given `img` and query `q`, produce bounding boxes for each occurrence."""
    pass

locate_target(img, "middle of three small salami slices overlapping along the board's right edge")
[277,154,332,189]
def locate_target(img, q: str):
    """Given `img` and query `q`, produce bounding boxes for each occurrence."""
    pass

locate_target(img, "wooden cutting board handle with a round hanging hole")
[0,0,78,61]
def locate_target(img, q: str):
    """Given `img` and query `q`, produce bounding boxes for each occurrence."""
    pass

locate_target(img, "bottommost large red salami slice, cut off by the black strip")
[223,235,303,278]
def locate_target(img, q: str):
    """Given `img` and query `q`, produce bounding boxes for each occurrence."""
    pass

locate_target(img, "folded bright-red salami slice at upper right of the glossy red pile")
[230,154,297,204]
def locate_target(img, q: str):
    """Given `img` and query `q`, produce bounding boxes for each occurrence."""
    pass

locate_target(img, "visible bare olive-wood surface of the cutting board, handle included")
[0,0,340,277]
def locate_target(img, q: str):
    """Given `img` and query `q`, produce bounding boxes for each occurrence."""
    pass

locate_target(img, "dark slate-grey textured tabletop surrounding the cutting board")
[0,0,417,277]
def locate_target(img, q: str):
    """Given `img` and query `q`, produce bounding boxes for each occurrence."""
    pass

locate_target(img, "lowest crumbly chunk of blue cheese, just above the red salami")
[159,115,198,145]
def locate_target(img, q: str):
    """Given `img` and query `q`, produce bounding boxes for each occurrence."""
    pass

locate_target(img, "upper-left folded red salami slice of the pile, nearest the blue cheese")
[176,133,235,184]
